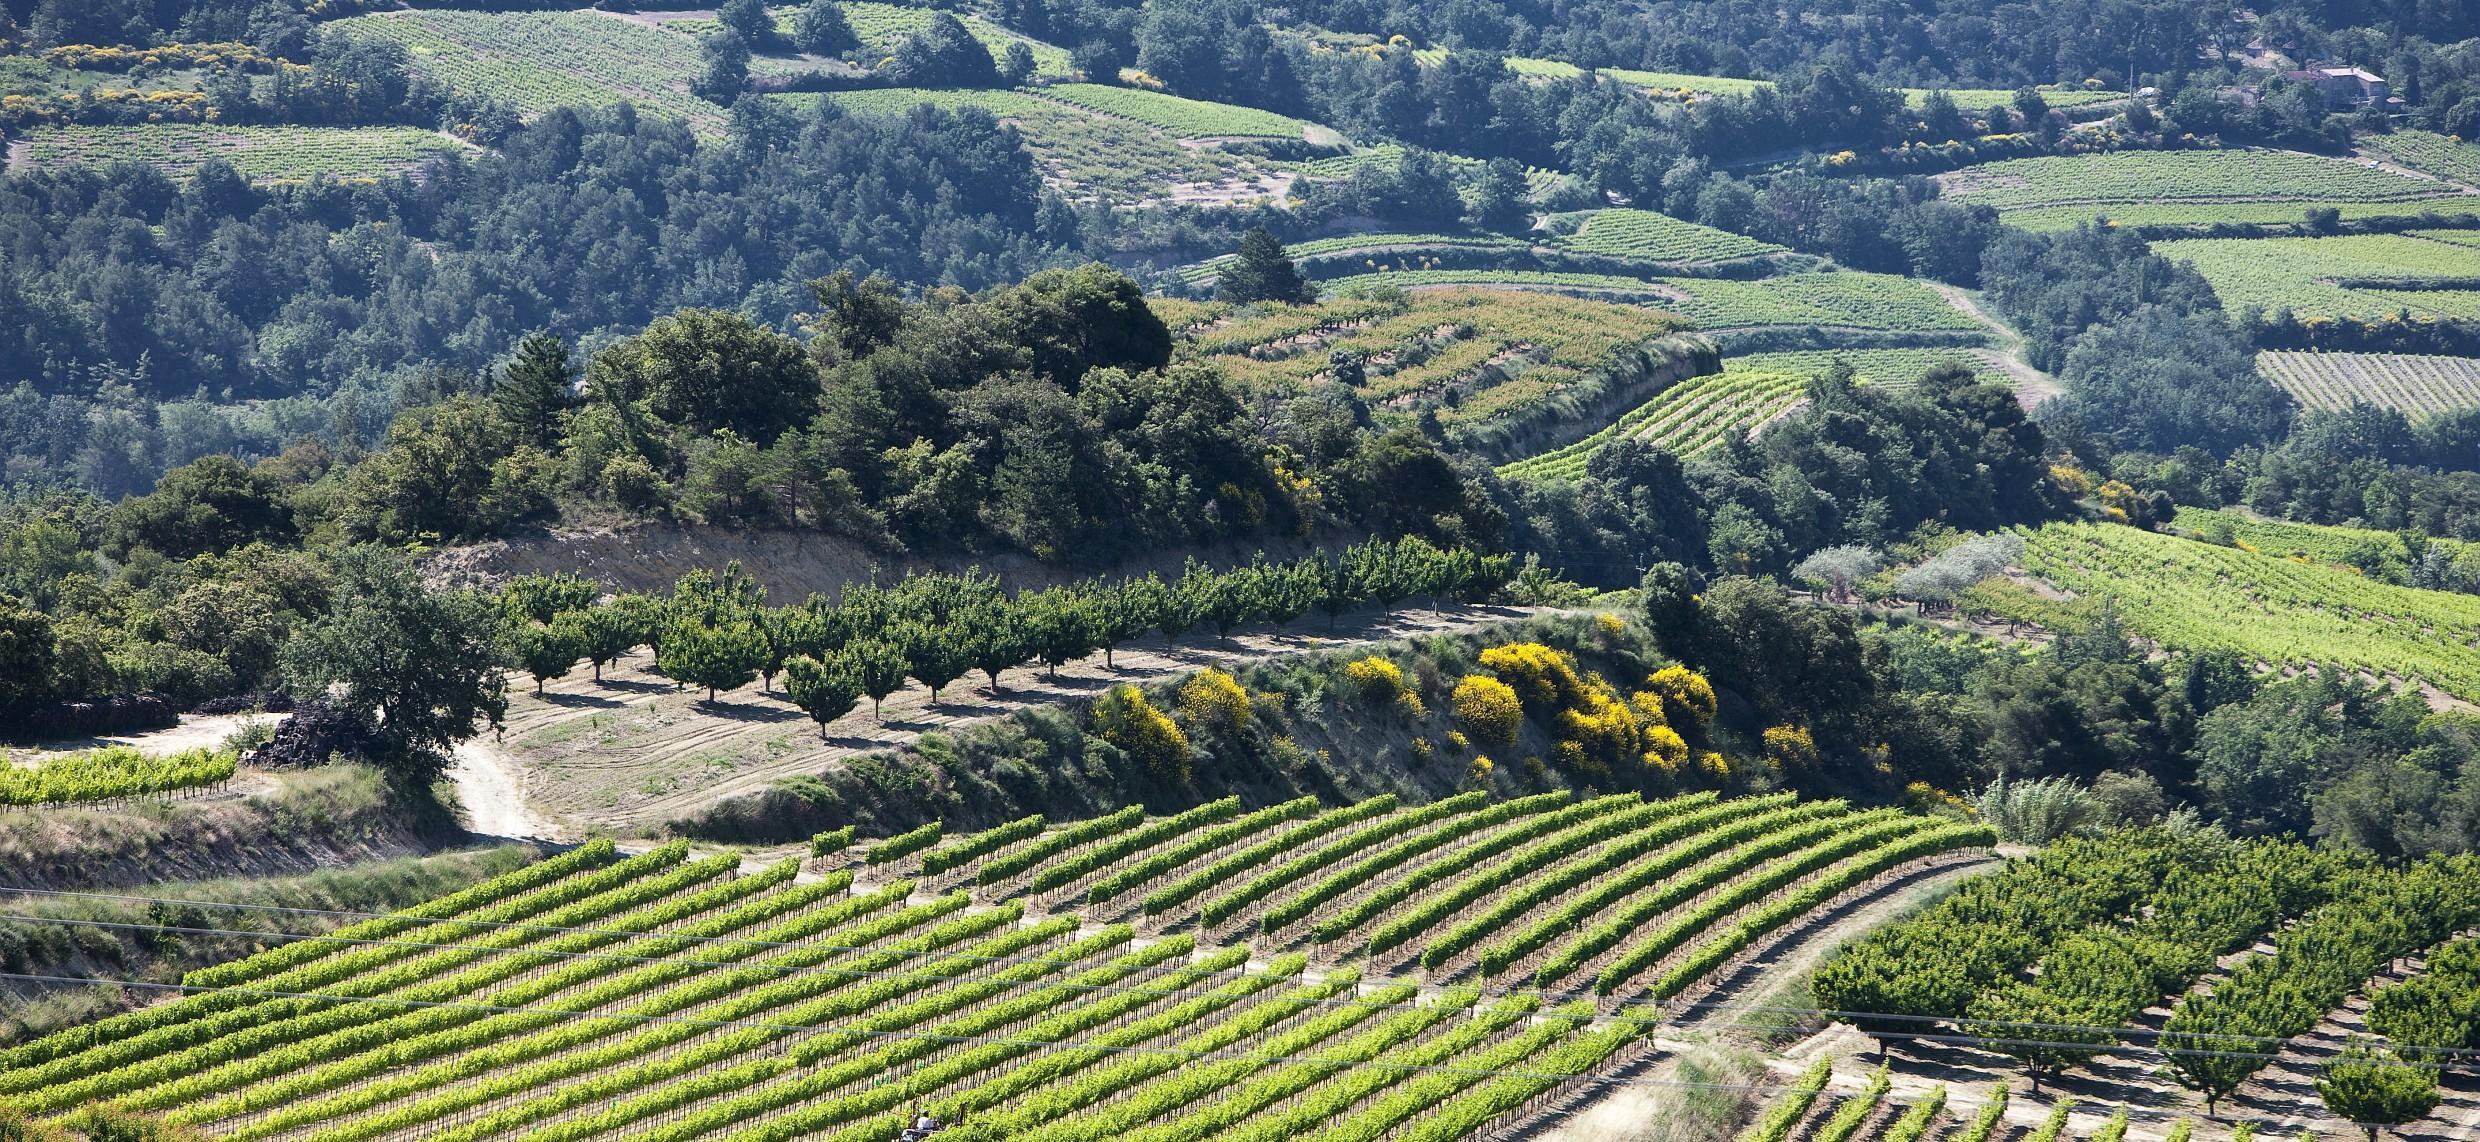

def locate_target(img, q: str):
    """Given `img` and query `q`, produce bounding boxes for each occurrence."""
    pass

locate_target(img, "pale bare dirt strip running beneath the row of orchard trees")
[459,608,1533,839]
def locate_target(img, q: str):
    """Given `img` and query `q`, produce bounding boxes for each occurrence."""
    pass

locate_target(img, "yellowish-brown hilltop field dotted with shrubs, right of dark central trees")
[1158,288,1686,425]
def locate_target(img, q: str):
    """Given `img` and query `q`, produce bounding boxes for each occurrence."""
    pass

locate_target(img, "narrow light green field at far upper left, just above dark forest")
[25,124,466,184]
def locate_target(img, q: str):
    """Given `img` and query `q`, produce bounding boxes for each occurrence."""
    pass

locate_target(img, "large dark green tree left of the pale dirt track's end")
[280,546,508,787]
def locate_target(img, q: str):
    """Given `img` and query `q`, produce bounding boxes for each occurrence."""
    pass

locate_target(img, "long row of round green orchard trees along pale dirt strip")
[501,539,1513,732]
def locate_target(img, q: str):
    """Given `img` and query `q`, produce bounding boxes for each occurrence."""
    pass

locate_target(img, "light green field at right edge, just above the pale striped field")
[2153,233,2480,320]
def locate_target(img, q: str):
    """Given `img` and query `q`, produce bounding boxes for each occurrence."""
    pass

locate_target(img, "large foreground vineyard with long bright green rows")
[0,794,1991,1142]
